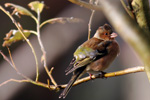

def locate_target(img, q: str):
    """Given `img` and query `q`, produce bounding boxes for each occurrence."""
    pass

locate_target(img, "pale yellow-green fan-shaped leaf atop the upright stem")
[28,1,45,13]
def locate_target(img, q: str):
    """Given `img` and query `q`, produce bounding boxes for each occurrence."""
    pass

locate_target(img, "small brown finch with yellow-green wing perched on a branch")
[59,24,120,99]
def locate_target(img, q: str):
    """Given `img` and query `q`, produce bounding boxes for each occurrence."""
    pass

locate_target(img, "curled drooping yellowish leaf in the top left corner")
[5,3,33,17]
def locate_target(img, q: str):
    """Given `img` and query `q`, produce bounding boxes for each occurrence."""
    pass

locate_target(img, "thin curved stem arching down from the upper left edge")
[0,6,39,82]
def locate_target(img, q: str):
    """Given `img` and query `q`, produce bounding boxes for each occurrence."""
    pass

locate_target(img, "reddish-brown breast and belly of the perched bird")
[86,41,119,74]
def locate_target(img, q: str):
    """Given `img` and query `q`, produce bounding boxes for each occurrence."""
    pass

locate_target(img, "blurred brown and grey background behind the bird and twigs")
[0,0,150,100]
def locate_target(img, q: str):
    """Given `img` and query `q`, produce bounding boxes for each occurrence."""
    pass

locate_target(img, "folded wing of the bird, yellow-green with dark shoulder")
[65,41,112,75]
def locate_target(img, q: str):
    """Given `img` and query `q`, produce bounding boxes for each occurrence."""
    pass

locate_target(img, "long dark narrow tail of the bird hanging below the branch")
[59,68,83,99]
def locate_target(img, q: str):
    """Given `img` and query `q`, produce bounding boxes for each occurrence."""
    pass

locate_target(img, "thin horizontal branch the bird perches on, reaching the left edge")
[0,66,144,91]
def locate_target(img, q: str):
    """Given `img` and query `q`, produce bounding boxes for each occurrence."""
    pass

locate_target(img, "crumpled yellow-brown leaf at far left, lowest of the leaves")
[2,30,31,47]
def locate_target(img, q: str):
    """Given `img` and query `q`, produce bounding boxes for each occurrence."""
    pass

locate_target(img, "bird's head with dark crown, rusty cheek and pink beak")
[94,24,117,40]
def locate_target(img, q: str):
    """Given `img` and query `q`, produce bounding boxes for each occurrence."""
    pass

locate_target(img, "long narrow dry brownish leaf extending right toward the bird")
[40,17,83,27]
